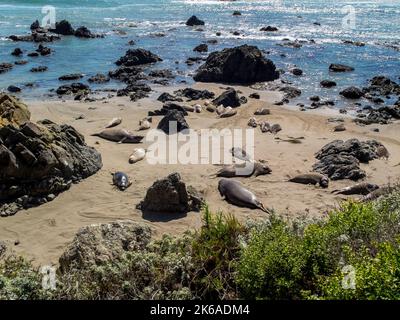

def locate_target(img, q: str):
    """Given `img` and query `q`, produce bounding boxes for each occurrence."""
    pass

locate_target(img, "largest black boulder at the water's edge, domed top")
[193,45,279,84]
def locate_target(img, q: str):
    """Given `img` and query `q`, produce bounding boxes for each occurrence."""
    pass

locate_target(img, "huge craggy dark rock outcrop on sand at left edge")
[0,120,102,216]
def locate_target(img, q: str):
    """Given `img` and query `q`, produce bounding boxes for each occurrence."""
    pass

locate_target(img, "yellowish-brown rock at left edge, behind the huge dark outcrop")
[0,93,31,127]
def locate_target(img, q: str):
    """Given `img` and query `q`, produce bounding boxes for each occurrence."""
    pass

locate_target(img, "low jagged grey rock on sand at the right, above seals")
[313,139,383,180]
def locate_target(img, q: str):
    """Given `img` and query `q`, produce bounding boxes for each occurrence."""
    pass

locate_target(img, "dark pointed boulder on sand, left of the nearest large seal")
[139,172,203,214]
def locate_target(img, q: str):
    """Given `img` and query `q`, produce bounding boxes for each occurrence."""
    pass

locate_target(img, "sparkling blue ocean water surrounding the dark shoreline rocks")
[0,0,400,106]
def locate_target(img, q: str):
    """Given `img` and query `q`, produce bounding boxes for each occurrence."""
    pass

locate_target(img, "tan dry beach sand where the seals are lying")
[0,84,400,265]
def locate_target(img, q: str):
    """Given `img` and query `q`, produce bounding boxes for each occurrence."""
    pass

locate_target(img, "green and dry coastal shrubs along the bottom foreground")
[0,189,400,299]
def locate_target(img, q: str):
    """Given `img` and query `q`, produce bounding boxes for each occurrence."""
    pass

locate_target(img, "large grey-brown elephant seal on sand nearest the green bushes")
[218,178,270,213]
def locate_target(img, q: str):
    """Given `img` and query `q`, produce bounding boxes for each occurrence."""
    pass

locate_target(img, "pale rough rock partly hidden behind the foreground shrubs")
[59,221,151,273]
